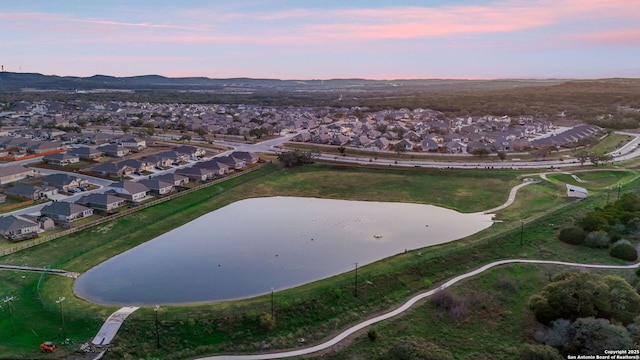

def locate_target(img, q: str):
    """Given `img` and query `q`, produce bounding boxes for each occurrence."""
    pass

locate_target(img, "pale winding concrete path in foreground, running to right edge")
[198,259,640,360]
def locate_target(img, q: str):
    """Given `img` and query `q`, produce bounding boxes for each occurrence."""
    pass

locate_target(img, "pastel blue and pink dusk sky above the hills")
[0,0,640,80]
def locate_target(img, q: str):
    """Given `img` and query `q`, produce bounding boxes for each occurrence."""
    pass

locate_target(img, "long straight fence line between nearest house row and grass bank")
[0,164,264,257]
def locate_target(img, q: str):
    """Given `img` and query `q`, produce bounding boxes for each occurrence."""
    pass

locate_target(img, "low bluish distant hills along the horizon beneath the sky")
[0,72,565,92]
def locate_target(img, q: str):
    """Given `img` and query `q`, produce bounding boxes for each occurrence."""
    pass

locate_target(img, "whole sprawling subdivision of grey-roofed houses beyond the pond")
[0,101,602,241]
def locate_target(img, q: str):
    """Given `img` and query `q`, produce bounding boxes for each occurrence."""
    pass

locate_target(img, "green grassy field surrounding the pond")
[0,164,637,359]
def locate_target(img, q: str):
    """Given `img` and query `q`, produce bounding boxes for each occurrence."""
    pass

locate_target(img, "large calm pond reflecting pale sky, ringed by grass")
[74,197,492,306]
